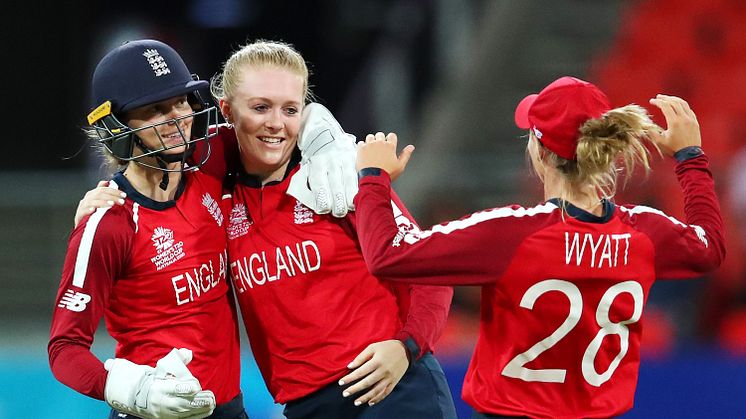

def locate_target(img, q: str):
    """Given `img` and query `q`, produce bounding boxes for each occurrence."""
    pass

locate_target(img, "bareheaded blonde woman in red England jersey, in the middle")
[206,41,455,419]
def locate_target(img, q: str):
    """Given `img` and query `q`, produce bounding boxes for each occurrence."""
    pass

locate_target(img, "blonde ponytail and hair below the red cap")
[532,105,661,203]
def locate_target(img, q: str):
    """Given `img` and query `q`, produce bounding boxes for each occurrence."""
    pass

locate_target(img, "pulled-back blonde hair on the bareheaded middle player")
[210,39,312,102]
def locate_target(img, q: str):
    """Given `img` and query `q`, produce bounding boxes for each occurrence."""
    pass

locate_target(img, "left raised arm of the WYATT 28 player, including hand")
[355,133,536,285]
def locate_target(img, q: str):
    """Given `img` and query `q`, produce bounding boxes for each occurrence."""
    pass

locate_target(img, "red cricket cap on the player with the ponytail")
[515,76,611,160]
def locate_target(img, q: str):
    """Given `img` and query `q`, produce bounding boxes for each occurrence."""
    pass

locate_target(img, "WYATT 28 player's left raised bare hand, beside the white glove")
[356,132,414,181]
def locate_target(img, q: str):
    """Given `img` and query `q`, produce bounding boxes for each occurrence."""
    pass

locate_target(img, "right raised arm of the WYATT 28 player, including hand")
[639,95,725,278]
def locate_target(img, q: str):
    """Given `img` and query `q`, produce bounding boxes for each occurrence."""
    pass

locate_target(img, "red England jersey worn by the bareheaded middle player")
[226,153,453,403]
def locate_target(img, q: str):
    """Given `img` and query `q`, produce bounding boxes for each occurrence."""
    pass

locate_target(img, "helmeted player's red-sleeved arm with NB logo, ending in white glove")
[48,208,215,419]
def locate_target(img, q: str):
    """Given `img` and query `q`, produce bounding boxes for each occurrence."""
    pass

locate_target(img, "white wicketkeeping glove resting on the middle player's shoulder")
[288,103,357,217]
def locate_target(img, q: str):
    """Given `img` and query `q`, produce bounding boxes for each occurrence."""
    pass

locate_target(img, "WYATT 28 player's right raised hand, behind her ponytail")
[650,95,702,156]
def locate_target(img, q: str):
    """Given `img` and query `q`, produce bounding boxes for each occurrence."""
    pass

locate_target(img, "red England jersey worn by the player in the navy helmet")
[49,144,240,404]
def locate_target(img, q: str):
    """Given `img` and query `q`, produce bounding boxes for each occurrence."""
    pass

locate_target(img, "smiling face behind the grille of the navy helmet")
[124,95,194,158]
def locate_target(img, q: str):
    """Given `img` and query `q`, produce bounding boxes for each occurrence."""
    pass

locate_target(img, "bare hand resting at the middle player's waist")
[339,340,409,406]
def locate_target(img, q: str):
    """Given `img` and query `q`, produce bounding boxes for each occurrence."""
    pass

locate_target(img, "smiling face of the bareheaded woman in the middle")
[220,65,305,181]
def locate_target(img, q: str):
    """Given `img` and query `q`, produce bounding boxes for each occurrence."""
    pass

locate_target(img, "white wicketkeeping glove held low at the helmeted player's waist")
[104,348,215,419]
